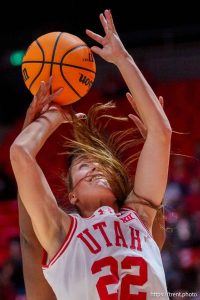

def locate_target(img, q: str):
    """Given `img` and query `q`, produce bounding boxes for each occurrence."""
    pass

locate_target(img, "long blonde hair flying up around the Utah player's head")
[64,102,144,206]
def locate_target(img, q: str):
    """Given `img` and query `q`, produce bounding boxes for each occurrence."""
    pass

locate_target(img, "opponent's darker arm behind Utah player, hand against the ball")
[14,78,85,300]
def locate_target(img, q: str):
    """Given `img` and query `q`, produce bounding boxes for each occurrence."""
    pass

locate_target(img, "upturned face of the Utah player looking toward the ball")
[71,158,116,210]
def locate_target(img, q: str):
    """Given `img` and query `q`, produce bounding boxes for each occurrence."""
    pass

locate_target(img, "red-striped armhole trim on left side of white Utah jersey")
[42,216,77,269]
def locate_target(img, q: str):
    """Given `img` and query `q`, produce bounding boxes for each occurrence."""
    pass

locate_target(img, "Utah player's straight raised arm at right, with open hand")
[86,10,172,227]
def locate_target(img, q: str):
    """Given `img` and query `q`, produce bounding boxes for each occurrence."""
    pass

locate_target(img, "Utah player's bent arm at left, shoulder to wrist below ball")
[10,77,71,256]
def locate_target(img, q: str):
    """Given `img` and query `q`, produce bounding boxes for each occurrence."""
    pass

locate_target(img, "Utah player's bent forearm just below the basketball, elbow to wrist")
[13,110,62,157]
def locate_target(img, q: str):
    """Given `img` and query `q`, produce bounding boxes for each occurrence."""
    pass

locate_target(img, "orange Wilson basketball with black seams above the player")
[22,32,96,105]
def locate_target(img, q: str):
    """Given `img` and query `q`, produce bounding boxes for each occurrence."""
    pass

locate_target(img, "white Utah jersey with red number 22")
[42,206,169,300]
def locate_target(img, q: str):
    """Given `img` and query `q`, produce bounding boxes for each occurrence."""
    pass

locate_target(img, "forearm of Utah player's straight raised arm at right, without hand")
[116,52,170,132]
